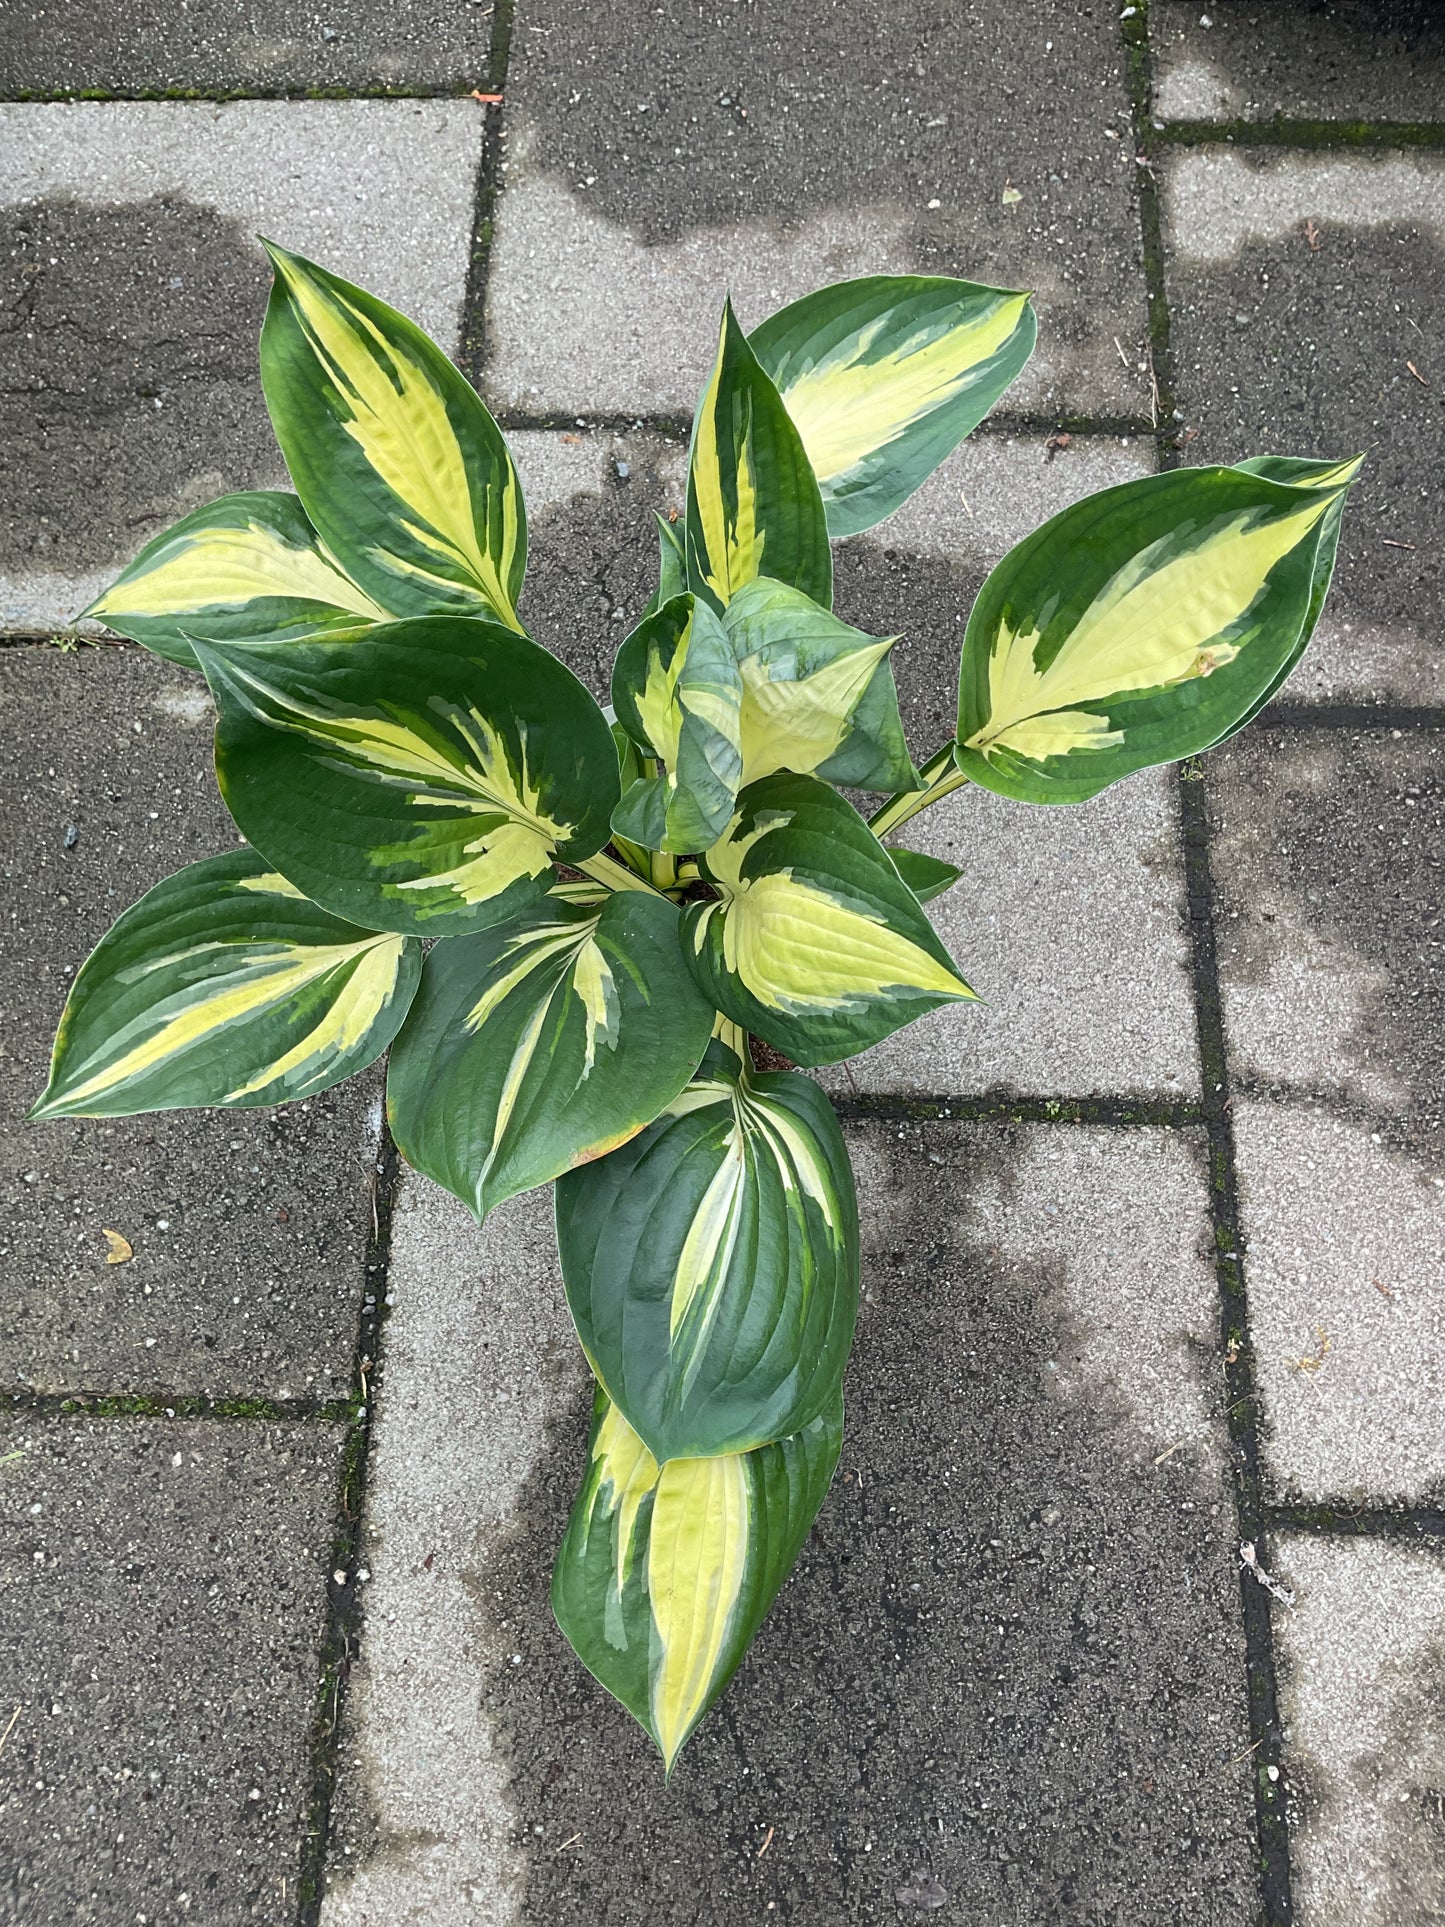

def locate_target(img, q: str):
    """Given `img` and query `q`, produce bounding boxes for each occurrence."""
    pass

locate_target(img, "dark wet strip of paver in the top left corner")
[0,0,491,98]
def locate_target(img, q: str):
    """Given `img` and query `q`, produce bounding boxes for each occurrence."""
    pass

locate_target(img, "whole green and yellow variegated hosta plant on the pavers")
[33,249,1356,1769]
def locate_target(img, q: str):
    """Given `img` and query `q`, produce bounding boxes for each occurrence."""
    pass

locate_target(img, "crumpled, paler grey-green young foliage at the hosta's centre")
[613,576,919,850]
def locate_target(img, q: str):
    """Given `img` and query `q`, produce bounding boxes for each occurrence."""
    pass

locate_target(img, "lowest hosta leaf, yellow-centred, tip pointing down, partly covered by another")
[551,1391,842,1773]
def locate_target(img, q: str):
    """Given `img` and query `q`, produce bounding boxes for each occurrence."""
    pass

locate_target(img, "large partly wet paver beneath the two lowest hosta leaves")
[322,1125,1254,1927]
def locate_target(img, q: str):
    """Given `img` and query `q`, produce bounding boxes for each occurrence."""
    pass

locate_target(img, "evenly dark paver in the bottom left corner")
[0,1412,341,1927]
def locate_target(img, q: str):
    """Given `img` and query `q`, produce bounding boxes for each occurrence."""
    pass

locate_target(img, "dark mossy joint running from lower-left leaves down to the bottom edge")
[297,1118,401,1927]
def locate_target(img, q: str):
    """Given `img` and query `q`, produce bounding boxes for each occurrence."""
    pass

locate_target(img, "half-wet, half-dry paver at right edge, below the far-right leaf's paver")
[1210,728,1445,1499]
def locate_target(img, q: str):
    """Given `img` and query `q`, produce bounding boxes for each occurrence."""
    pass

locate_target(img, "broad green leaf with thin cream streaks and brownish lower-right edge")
[387,884,713,1220]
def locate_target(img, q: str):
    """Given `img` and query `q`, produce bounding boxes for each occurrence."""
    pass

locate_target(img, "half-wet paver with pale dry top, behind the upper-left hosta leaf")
[0,100,482,630]
